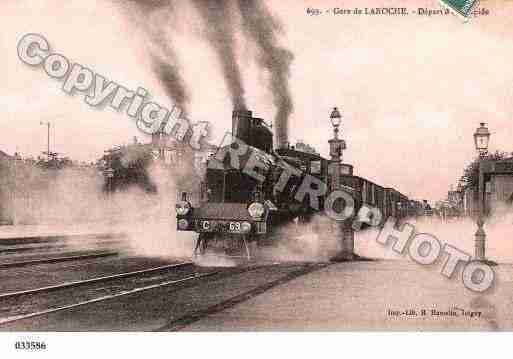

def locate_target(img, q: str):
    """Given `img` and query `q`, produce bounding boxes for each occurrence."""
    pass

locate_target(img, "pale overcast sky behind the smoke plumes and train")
[0,0,513,200]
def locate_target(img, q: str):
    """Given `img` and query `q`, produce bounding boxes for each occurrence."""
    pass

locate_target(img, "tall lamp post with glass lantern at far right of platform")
[474,122,490,262]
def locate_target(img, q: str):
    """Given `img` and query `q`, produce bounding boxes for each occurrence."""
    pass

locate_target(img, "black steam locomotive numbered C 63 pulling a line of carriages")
[176,110,420,257]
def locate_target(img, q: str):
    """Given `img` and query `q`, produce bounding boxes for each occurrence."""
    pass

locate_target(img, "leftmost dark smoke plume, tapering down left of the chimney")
[123,0,189,112]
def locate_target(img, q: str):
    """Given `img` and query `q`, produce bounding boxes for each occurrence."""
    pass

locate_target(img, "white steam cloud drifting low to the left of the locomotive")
[0,159,197,259]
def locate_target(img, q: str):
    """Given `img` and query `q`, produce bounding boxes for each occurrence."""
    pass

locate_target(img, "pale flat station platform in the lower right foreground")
[182,260,513,331]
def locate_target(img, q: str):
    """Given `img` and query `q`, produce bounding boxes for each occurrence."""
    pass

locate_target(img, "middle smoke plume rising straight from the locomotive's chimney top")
[193,0,246,110]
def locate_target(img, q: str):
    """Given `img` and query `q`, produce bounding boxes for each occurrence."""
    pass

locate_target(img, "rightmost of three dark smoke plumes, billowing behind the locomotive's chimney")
[238,0,294,145]
